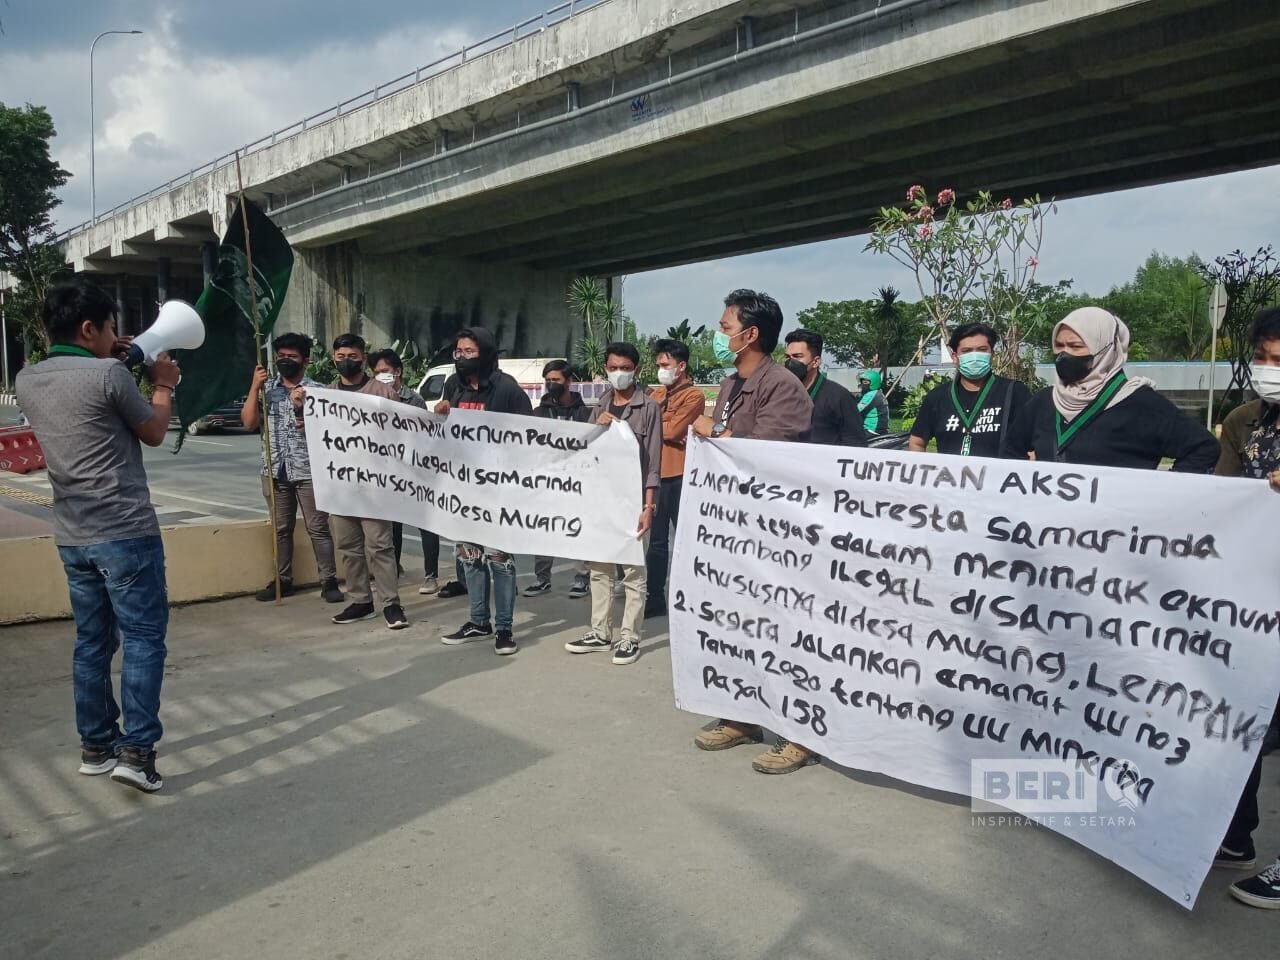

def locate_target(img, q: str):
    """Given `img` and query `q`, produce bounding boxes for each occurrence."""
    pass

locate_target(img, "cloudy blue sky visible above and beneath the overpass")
[0,0,1280,332]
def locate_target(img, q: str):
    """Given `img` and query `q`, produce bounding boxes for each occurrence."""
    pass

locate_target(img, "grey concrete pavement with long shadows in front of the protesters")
[0,577,1280,960]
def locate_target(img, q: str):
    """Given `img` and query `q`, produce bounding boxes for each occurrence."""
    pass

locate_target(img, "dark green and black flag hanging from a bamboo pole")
[174,200,293,453]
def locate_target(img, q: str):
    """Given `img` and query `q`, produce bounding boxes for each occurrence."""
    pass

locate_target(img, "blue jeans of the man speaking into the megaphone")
[58,536,169,753]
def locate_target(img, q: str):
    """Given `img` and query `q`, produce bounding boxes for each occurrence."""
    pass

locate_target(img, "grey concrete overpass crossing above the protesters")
[47,0,1280,353]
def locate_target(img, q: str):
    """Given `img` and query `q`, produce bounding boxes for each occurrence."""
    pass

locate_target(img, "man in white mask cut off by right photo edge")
[1213,307,1280,910]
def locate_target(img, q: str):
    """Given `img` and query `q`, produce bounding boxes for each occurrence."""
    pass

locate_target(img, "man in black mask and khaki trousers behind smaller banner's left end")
[292,333,408,630]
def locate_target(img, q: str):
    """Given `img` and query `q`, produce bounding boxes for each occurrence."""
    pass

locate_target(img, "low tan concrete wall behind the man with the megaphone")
[0,520,320,623]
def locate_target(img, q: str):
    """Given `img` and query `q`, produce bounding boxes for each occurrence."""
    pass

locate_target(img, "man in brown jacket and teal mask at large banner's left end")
[694,291,819,773]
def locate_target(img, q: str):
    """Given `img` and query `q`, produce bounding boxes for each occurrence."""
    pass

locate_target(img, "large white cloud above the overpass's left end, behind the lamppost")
[0,15,467,227]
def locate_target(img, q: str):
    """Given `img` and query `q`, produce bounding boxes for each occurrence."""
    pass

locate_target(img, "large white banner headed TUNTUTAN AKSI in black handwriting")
[671,439,1280,909]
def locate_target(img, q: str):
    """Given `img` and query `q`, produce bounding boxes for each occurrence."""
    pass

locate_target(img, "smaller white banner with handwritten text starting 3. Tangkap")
[296,388,644,564]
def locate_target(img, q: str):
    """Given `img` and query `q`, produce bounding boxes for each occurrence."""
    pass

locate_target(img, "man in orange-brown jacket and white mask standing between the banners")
[644,340,707,618]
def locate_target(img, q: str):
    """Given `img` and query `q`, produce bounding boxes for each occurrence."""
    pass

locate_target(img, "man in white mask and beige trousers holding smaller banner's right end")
[564,343,662,664]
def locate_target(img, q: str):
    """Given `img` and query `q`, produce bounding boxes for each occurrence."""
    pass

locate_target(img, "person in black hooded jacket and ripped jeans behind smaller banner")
[435,326,534,657]
